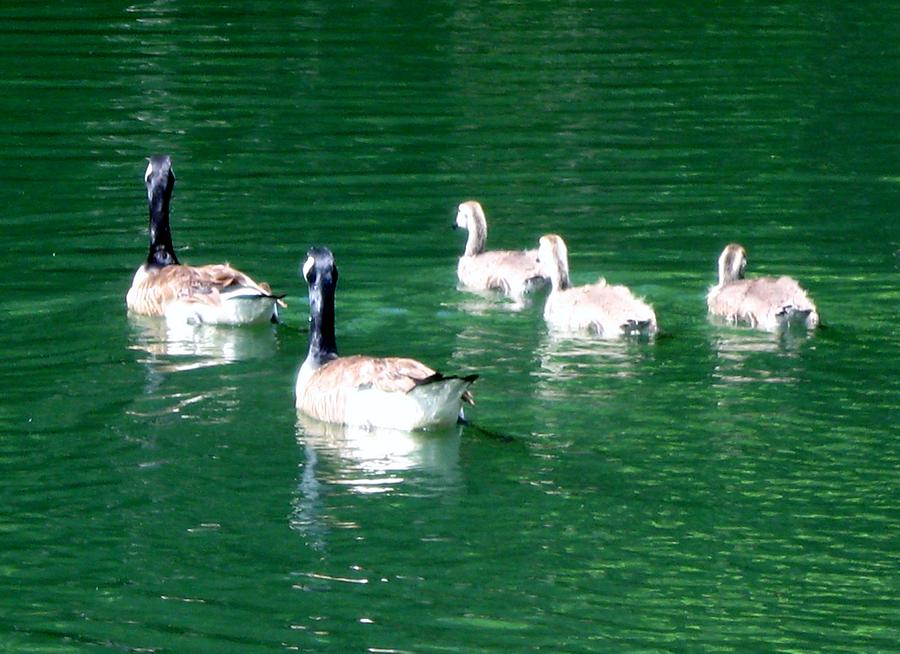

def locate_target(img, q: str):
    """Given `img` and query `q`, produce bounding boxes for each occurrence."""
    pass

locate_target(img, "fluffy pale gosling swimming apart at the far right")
[706,243,819,331]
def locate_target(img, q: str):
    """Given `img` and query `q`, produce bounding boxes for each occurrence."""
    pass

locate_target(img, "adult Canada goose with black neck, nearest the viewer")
[295,247,478,431]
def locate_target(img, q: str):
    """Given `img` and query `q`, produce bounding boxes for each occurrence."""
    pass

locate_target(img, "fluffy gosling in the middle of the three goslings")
[538,234,658,338]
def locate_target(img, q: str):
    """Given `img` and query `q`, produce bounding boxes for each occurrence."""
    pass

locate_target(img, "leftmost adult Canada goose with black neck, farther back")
[125,155,284,325]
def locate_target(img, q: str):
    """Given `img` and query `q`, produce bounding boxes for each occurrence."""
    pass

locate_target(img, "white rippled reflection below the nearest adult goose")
[290,414,462,550]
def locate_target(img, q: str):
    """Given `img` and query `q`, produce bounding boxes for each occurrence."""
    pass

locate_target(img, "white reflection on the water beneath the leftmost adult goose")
[129,316,275,372]
